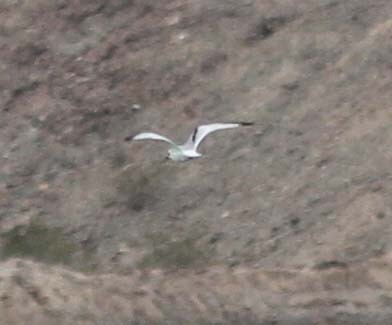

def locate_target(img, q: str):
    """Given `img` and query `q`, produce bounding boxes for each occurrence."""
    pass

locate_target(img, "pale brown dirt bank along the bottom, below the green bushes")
[0,256,392,325]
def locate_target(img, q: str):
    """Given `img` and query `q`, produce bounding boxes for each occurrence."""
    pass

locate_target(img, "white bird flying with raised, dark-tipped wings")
[125,122,253,161]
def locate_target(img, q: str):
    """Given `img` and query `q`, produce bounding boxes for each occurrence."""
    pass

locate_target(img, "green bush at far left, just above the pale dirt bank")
[1,222,77,265]
